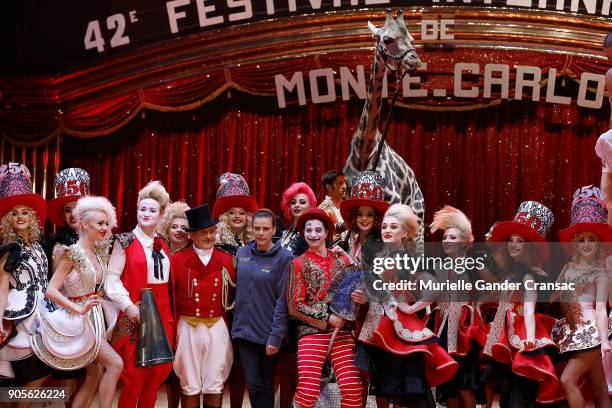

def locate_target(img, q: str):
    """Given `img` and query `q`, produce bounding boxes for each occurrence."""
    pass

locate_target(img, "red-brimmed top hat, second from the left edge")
[47,167,90,227]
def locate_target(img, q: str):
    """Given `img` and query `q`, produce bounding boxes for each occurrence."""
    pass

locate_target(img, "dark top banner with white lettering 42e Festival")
[3,0,612,73]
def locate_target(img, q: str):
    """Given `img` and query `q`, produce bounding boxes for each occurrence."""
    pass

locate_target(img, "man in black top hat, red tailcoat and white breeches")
[173,204,236,408]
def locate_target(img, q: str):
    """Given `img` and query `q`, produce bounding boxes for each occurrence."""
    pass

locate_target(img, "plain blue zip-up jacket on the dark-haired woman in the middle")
[232,241,293,347]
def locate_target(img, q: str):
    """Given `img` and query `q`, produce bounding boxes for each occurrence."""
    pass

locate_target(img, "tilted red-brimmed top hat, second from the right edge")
[491,201,555,262]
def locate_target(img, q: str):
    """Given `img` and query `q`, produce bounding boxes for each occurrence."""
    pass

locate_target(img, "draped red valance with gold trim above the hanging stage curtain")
[0,48,608,146]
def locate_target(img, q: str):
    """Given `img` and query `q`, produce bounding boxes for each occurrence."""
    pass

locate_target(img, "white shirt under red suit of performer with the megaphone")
[104,226,170,312]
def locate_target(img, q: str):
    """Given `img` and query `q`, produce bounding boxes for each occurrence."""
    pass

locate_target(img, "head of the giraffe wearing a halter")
[368,9,421,71]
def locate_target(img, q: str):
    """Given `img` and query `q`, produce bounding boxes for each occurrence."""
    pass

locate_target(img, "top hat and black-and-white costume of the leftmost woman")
[0,163,55,385]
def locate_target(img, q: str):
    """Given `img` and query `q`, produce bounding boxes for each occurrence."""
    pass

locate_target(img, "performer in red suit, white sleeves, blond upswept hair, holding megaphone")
[105,181,176,408]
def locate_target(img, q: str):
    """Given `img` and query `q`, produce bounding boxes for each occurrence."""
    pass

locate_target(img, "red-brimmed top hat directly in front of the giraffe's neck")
[340,171,389,222]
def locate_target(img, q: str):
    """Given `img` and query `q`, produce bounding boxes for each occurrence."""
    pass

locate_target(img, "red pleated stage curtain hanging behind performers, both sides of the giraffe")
[62,92,608,239]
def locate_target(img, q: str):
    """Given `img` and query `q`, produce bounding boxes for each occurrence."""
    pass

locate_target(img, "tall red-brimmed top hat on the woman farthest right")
[559,185,612,245]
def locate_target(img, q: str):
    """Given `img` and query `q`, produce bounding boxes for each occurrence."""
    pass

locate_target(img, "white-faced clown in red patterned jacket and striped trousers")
[287,208,362,408]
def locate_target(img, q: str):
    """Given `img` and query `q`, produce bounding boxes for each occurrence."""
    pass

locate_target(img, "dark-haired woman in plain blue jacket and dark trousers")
[232,209,293,408]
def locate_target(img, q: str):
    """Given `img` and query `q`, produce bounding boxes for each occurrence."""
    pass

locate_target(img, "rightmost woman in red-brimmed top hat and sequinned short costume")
[553,186,612,408]
